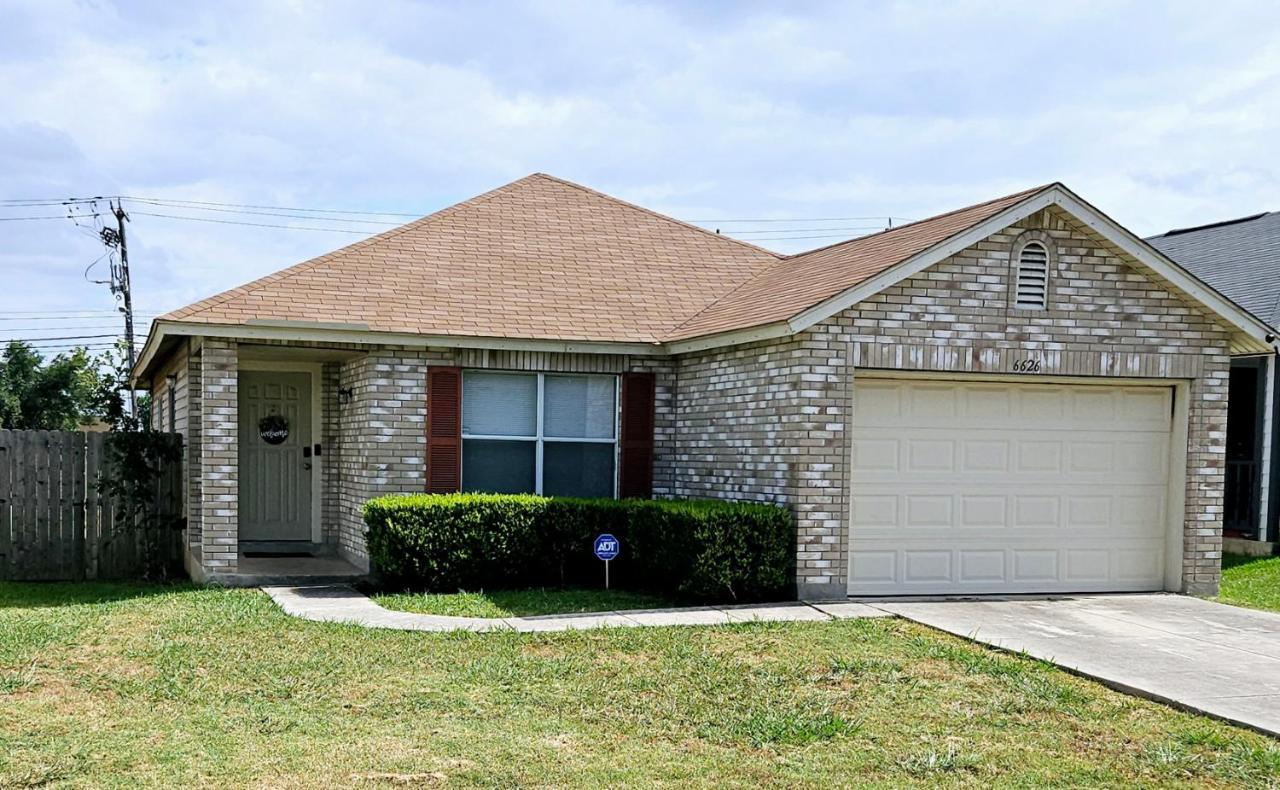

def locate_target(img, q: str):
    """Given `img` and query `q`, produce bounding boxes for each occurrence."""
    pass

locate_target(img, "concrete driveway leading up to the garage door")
[873,594,1280,736]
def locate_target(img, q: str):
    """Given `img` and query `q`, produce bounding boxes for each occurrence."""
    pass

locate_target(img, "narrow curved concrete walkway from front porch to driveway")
[262,584,888,631]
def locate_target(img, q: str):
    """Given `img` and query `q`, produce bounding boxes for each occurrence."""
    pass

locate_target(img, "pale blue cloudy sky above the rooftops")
[0,0,1280,348]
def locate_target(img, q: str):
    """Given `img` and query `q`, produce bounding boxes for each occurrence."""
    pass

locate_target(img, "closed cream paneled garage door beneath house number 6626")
[849,376,1172,595]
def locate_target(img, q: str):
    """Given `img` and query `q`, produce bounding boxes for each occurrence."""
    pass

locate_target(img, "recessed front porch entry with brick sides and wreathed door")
[177,337,425,586]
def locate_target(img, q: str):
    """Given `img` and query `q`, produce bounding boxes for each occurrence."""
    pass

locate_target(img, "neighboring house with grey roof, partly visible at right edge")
[1147,211,1280,553]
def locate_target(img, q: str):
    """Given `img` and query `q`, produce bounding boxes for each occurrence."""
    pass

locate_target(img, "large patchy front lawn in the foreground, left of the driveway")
[0,584,1280,787]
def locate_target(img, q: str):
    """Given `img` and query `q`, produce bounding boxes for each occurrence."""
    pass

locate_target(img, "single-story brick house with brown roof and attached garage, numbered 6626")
[136,174,1272,598]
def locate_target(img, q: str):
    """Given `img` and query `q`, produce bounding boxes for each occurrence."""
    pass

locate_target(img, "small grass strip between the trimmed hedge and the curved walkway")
[372,589,676,617]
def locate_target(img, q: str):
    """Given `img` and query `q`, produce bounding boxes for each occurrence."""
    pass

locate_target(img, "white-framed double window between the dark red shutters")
[462,370,618,497]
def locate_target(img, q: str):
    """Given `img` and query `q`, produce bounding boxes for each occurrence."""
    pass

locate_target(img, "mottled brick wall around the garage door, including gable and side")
[675,209,1230,597]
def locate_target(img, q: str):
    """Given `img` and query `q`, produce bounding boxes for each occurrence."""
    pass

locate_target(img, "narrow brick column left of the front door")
[200,338,239,574]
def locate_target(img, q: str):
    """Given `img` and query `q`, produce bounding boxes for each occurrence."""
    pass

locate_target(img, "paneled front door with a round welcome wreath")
[239,370,315,540]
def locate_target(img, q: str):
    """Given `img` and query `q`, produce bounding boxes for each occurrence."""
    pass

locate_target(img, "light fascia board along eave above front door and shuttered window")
[133,320,666,380]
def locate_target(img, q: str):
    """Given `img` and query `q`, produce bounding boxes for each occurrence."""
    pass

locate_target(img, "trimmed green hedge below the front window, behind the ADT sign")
[365,494,795,602]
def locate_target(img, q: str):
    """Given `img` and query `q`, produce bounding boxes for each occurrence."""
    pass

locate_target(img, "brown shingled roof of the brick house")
[159,173,1046,343]
